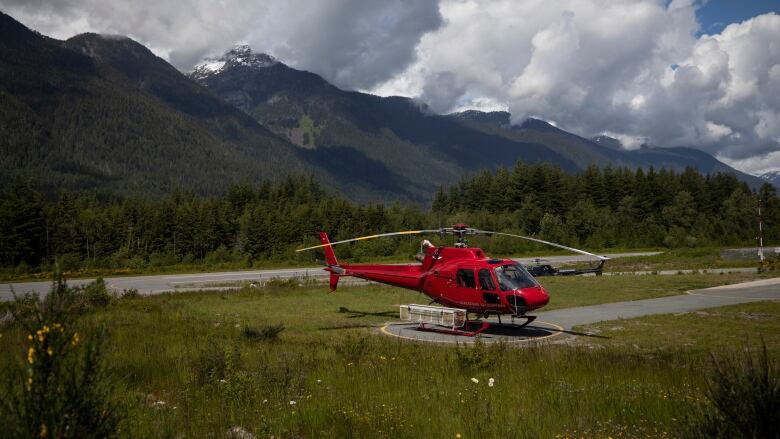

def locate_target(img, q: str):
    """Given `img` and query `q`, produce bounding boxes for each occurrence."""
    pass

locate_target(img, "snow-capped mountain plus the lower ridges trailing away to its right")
[190,46,757,191]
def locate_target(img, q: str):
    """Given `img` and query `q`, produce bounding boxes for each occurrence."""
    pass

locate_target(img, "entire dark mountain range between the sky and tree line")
[0,9,764,203]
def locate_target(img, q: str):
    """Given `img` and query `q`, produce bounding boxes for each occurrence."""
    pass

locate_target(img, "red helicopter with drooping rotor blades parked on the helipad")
[297,224,609,335]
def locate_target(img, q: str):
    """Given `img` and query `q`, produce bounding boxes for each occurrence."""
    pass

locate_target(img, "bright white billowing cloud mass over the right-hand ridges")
[374,0,780,174]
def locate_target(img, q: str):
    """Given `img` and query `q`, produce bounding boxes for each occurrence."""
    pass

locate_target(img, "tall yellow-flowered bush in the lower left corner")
[0,275,121,438]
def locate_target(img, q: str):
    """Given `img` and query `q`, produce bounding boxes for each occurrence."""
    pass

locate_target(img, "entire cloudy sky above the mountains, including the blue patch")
[0,0,780,173]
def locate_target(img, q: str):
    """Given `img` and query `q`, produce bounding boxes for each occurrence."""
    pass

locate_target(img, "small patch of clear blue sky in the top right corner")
[696,0,780,34]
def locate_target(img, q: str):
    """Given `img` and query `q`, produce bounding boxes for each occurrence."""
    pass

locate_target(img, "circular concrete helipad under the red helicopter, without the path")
[381,320,563,344]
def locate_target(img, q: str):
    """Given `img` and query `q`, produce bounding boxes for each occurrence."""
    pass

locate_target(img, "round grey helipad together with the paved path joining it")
[381,278,780,344]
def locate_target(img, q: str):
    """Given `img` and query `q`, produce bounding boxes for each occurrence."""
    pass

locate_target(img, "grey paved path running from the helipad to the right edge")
[536,278,780,329]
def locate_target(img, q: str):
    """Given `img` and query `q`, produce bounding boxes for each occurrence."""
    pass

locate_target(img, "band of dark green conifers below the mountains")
[0,163,780,271]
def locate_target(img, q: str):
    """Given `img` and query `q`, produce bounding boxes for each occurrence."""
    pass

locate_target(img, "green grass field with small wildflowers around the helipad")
[0,274,780,438]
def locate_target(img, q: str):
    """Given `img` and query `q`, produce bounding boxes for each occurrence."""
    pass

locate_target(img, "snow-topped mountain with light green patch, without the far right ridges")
[190,46,578,199]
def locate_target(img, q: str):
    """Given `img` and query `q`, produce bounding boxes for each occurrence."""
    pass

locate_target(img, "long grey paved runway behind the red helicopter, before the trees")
[0,252,659,301]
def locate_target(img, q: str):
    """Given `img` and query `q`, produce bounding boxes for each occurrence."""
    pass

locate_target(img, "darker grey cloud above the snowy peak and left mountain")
[0,0,442,88]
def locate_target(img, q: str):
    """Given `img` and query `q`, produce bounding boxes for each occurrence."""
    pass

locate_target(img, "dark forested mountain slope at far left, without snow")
[0,14,348,196]
